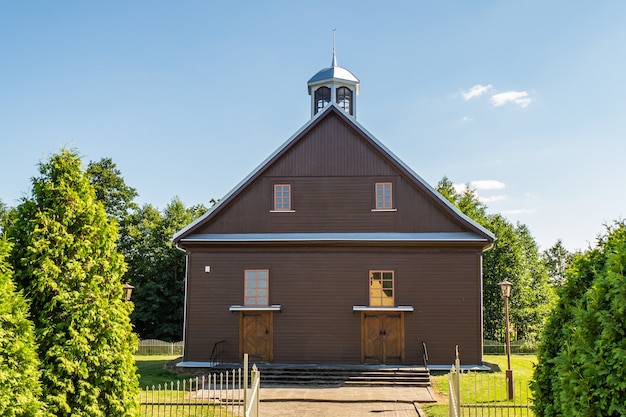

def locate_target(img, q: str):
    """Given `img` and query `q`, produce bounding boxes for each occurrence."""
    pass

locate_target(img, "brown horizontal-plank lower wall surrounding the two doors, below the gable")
[185,247,482,364]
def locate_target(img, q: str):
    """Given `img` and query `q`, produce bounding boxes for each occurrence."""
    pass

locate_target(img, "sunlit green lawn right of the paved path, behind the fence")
[423,355,537,417]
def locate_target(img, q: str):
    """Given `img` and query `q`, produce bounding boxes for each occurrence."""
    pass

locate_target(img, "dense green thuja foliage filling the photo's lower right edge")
[532,222,626,416]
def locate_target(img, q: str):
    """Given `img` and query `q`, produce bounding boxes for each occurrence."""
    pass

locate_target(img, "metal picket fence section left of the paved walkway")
[140,355,261,417]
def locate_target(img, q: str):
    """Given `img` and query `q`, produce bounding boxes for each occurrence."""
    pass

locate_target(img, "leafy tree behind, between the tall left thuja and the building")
[120,198,206,341]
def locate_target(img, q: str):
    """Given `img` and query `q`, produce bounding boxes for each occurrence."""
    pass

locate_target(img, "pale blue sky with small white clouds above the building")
[0,0,626,250]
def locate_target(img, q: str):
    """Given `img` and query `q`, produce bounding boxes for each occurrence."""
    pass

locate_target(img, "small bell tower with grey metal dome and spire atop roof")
[307,32,359,119]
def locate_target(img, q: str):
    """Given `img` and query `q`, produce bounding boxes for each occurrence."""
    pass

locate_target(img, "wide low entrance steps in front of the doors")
[247,364,430,387]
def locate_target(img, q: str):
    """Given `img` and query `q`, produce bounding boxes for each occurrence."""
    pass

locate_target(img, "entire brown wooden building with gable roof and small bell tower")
[174,54,494,366]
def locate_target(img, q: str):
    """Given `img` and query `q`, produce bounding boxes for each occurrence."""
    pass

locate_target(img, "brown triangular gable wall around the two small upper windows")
[198,116,466,233]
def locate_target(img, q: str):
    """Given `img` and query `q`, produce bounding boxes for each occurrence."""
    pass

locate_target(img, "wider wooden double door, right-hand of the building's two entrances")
[361,312,404,364]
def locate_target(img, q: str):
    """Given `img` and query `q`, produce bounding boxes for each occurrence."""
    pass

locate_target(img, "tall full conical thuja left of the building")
[8,150,139,416]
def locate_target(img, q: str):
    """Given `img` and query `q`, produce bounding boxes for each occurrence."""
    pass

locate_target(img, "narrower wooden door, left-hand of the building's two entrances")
[239,311,273,362]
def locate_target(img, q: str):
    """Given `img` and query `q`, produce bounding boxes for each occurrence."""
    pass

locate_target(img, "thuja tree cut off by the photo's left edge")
[0,238,43,417]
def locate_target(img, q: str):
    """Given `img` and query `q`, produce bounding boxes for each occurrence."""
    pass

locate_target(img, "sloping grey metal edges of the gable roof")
[172,102,495,244]
